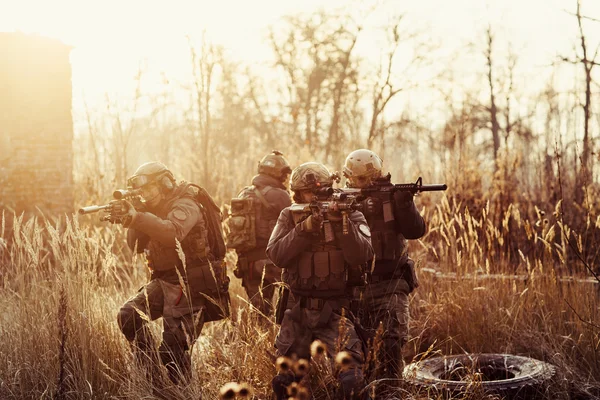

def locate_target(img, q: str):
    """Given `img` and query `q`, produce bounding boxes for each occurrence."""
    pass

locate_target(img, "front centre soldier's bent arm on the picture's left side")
[267,209,311,268]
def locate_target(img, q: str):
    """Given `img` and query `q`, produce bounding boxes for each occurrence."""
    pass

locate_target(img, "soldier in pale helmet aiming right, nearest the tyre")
[343,149,425,388]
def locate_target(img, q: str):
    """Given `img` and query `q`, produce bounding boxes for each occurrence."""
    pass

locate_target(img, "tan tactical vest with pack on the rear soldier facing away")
[227,185,279,253]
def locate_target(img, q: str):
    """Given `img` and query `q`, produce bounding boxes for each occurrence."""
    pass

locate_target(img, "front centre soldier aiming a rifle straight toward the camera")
[267,162,373,399]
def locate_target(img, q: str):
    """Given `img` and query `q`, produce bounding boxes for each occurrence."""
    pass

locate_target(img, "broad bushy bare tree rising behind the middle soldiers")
[269,10,362,158]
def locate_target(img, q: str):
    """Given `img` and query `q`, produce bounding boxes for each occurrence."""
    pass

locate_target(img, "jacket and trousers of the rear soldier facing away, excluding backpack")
[234,174,292,315]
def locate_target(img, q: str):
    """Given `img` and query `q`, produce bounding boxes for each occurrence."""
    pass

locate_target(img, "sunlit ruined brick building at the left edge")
[0,32,73,216]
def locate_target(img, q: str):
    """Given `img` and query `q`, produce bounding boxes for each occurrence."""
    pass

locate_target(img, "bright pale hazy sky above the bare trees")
[0,0,600,131]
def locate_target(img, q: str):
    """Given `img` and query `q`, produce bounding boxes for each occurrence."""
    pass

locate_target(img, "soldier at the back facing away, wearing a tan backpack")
[227,150,292,316]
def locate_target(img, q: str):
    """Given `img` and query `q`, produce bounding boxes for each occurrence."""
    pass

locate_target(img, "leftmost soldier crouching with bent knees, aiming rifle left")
[117,162,229,383]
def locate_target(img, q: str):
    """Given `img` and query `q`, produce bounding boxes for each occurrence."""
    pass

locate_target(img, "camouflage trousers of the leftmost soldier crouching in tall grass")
[117,279,205,383]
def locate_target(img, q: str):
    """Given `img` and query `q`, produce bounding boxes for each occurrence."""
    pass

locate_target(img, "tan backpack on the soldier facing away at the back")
[227,185,273,252]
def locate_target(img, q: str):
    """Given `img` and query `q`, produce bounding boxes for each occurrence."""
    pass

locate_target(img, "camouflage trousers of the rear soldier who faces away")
[242,260,281,316]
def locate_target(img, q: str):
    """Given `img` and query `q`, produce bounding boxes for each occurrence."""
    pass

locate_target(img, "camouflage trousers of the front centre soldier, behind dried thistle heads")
[273,301,364,399]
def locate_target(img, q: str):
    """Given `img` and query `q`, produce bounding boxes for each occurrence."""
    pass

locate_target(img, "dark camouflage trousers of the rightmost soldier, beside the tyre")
[358,279,410,379]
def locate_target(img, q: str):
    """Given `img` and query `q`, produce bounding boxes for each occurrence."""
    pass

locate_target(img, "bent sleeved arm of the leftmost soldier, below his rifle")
[130,199,202,247]
